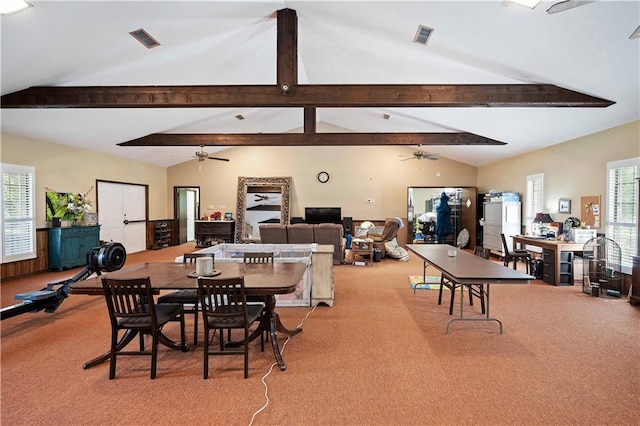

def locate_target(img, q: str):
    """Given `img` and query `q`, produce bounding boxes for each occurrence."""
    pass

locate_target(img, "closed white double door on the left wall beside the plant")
[98,182,147,253]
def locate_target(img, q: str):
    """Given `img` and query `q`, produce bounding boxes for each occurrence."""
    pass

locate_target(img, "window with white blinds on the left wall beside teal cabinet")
[0,164,36,263]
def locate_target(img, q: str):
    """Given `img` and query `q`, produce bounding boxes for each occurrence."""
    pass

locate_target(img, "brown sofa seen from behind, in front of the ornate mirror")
[259,223,347,265]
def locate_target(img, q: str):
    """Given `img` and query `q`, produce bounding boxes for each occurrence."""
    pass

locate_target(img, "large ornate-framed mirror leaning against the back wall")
[236,176,293,243]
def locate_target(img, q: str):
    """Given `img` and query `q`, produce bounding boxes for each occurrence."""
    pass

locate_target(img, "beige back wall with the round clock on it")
[167,146,476,220]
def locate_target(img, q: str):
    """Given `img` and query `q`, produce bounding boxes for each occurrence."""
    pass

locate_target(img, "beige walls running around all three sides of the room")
[0,121,640,233]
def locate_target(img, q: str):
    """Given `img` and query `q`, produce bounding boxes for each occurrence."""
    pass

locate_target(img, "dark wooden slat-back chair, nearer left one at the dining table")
[102,277,186,379]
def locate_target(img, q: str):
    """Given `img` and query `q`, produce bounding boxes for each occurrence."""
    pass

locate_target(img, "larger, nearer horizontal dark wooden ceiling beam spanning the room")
[2,84,614,108]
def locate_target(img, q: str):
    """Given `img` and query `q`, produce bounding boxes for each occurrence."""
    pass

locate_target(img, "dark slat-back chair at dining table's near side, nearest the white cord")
[198,277,264,379]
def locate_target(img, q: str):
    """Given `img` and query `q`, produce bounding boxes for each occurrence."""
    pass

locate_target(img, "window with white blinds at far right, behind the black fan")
[606,157,640,275]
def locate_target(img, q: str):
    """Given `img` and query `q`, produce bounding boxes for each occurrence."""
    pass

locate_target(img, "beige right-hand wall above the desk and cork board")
[477,121,640,231]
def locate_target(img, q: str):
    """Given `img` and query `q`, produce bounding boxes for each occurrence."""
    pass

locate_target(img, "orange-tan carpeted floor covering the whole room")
[1,243,640,425]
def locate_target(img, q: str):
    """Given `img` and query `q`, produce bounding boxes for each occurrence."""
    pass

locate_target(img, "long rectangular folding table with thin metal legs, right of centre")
[407,244,534,334]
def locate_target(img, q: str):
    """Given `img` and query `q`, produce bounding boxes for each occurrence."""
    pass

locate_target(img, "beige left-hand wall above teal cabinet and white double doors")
[0,133,173,228]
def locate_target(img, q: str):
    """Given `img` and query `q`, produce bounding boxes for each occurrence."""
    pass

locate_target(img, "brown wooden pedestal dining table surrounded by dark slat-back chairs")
[70,262,306,371]
